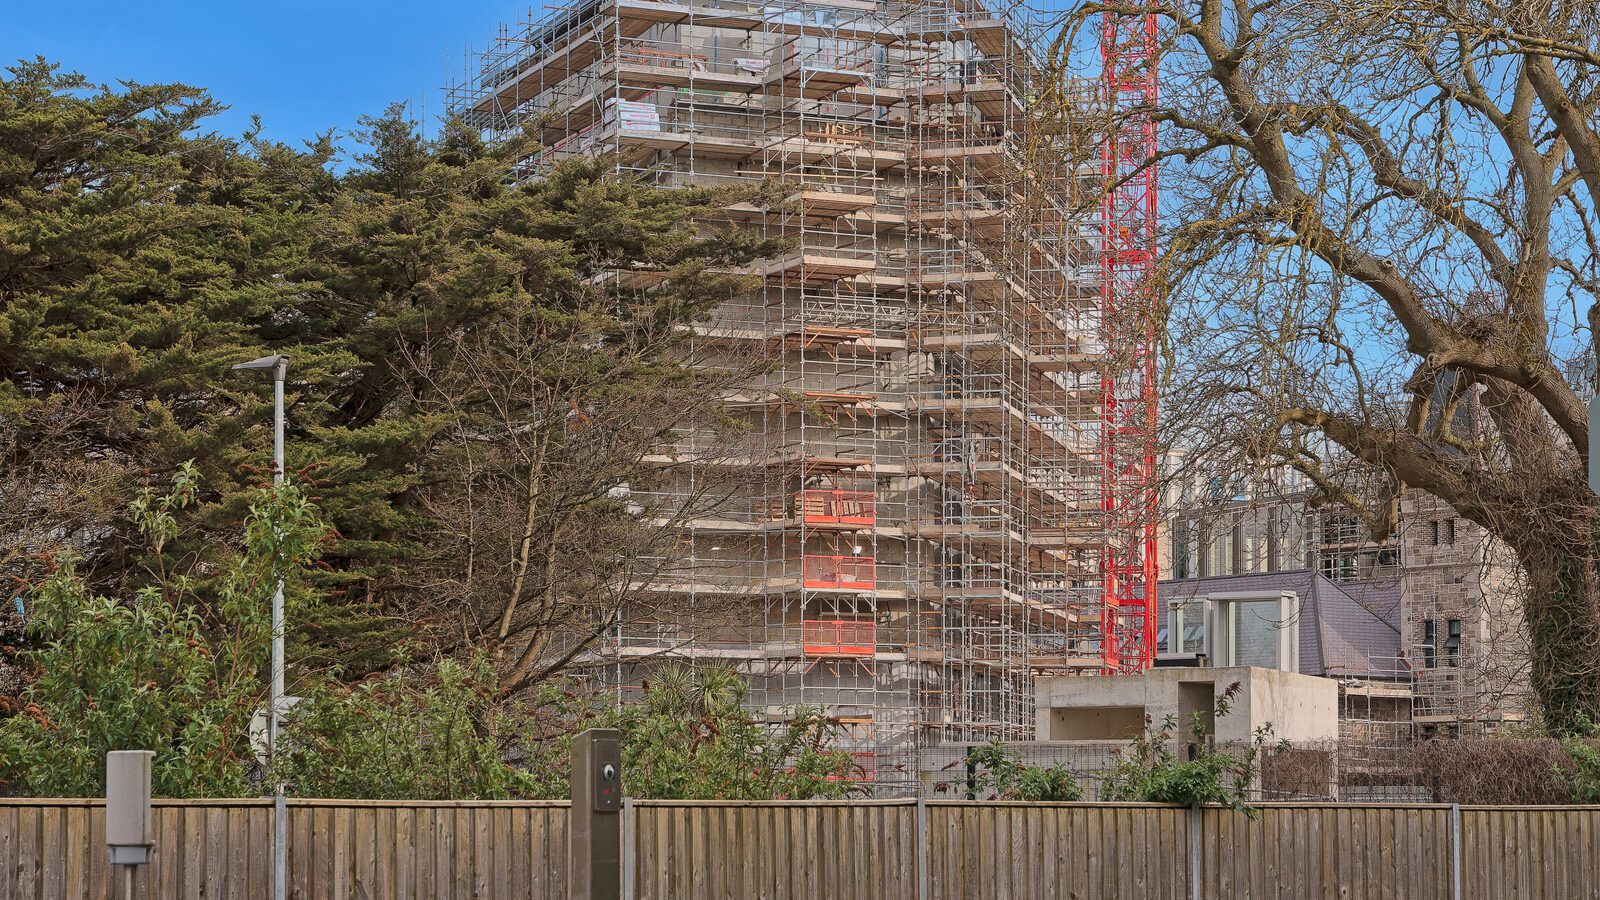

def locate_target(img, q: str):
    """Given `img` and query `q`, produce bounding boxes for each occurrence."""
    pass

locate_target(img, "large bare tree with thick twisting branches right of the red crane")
[1064,0,1600,730]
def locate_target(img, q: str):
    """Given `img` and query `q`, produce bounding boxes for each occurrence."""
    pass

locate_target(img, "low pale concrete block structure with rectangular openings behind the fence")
[1034,666,1339,743]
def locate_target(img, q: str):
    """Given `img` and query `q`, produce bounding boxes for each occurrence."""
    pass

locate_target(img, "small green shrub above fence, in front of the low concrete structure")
[1101,682,1270,817]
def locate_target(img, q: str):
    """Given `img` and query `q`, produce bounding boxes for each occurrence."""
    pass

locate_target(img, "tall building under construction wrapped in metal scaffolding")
[451,0,1155,793]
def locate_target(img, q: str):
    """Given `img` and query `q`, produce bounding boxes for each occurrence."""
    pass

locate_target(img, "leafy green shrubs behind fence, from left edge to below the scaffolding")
[0,466,858,799]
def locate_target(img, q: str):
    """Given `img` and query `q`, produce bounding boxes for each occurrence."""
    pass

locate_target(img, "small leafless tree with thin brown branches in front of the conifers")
[392,279,749,692]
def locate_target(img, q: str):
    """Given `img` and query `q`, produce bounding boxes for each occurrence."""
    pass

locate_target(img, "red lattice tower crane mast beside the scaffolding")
[1101,5,1160,673]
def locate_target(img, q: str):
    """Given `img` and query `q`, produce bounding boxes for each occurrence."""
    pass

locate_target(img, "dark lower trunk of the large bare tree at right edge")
[1512,525,1600,733]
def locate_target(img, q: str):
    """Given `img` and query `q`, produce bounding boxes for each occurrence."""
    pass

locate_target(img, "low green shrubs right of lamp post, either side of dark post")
[272,655,854,799]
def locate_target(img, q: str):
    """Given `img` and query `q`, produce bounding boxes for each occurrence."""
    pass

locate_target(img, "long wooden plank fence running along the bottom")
[0,799,1600,900]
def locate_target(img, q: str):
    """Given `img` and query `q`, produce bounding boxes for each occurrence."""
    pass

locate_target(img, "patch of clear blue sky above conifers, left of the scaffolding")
[0,0,515,143]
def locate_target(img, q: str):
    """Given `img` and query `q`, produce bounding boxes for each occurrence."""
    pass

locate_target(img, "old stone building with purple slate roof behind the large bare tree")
[1160,479,1528,740]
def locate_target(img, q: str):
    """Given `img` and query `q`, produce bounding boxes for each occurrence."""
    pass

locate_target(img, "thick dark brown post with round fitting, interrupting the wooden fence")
[566,729,622,900]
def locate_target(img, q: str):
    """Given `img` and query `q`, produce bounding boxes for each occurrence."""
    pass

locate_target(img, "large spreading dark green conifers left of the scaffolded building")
[0,61,776,681]
